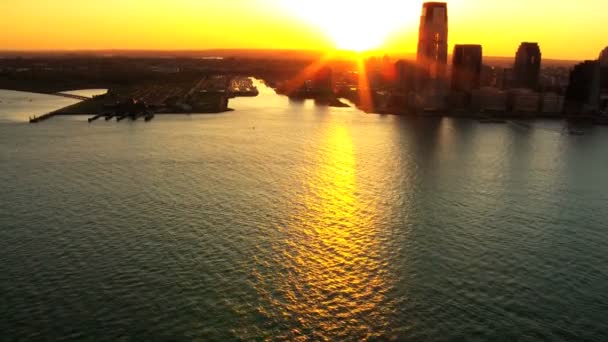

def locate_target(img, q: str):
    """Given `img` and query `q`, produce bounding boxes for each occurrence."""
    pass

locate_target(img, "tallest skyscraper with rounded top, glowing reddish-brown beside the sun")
[418,2,448,80]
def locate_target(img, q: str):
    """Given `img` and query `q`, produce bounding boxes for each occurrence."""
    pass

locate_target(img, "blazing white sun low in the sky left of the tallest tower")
[283,0,420,52]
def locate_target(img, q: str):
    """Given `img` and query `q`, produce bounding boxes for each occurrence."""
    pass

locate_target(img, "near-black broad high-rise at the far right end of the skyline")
[566,61,600,114]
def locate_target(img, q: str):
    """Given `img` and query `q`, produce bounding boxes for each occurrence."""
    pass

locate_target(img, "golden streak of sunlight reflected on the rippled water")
[256,127,386,340]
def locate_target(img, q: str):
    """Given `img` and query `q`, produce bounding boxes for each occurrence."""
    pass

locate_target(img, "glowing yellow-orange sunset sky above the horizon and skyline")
[0,0,608,59]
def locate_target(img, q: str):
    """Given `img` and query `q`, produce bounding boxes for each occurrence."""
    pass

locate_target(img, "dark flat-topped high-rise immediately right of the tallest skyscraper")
[452,45,482,93]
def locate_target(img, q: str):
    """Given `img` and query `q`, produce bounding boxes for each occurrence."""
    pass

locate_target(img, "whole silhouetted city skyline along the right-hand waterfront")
[338,2,608,116]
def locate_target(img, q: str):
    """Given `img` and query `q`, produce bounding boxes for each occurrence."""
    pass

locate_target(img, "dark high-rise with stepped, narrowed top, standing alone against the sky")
[513,43,542,89]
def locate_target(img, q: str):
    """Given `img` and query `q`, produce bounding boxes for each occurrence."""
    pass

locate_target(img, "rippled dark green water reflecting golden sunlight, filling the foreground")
[0,83,608,341]
